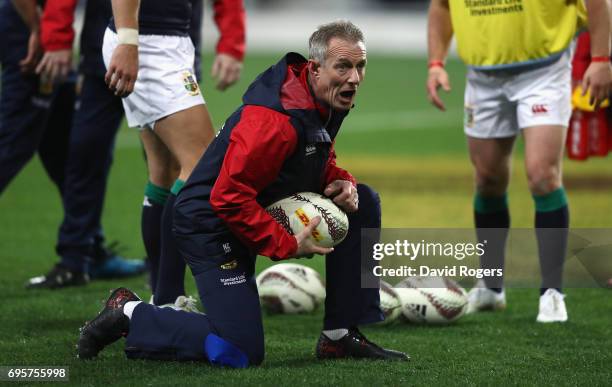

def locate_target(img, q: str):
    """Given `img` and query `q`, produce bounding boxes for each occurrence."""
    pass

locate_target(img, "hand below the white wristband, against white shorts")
[104,44,138,98]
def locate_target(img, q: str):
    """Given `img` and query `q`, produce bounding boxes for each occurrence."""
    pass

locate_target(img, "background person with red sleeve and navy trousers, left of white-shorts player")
[28,0,145,288]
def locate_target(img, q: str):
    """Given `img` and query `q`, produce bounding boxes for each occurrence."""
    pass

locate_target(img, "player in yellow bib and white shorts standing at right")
[427,0,612,322]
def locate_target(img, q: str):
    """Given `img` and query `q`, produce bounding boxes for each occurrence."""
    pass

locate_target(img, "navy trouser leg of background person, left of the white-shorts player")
[56,76,123,272]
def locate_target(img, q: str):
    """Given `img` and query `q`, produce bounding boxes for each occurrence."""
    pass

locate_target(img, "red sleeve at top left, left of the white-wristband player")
[40,0,77,51]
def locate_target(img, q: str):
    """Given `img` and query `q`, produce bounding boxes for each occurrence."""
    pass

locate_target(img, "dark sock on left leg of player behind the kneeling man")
[140,182,170,294]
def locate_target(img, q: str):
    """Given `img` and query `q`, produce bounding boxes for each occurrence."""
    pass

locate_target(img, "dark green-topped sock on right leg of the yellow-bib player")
[534,188,569,295]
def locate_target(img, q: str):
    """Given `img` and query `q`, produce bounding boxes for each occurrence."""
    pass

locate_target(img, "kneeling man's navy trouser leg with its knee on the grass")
[126,235,264,367]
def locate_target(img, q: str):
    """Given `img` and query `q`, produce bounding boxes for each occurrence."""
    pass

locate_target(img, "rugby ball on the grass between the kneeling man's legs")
[256,263,325,314]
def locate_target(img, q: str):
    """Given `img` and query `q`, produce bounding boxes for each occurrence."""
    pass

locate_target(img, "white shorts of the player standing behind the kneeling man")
[102,28,204,129]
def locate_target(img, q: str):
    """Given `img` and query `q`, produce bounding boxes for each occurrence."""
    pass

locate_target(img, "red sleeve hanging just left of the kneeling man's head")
[213,0,246,61]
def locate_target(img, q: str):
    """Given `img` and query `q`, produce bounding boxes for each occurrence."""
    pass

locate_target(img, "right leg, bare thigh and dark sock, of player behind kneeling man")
[148,104,214,305]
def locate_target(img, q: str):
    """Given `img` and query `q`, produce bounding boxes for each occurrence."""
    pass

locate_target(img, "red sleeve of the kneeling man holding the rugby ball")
[210,106,297,260]
